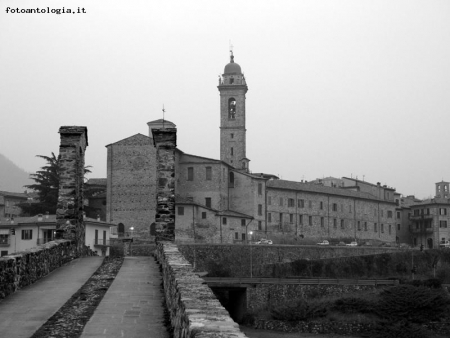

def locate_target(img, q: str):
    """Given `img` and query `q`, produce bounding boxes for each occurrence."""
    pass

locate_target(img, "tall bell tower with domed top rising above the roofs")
[217,51,249,171]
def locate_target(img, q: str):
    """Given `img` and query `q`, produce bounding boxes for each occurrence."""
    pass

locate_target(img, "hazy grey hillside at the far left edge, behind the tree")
[0,154,34,192]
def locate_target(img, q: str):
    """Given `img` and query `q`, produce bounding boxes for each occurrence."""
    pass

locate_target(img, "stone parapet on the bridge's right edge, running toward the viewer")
[156,242,247,338]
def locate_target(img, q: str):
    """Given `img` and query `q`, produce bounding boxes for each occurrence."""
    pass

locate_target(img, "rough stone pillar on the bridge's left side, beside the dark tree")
[56,126,88,254]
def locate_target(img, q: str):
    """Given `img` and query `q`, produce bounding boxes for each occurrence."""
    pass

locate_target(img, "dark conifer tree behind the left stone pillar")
[20,152,91,216]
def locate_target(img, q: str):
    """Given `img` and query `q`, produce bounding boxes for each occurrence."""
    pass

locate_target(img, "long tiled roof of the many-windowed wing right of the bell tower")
[267,180,394,204]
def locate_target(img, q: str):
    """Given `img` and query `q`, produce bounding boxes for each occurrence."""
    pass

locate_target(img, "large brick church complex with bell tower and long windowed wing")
[106,53,396,243]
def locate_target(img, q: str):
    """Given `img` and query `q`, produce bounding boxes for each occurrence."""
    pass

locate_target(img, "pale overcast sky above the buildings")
[0,0,450,198]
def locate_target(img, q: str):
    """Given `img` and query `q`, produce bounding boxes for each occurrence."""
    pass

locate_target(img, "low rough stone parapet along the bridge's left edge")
[0,239,77,299]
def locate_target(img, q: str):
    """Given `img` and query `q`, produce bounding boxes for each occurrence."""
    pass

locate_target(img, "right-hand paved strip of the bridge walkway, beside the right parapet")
[81,257,169,338]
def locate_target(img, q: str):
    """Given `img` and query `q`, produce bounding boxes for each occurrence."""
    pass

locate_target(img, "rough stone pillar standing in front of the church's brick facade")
[152,128,177,241]
